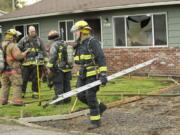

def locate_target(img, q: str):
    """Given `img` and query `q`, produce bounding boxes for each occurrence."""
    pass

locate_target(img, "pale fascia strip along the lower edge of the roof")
[0,1,180,22]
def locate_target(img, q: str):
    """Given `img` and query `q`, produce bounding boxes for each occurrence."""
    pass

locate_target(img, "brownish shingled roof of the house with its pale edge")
[0,0,180,22]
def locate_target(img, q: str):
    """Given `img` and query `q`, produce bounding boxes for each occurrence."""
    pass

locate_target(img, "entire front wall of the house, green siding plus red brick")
[2,5,180,76]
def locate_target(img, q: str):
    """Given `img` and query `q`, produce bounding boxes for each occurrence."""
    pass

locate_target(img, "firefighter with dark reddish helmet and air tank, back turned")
[47,30,72,104]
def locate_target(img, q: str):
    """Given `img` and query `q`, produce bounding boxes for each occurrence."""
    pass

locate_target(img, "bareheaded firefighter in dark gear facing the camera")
[18,26,46,98]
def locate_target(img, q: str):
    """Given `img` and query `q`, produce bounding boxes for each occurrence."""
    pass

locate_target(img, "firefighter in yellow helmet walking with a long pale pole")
[71,20,107,130]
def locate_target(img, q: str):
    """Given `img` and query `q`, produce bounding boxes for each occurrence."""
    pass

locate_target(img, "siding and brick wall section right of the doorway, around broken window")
[99,6,180,76]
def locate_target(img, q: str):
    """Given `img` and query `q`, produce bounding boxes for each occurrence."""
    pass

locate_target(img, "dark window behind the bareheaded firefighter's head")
[15,24,39,41]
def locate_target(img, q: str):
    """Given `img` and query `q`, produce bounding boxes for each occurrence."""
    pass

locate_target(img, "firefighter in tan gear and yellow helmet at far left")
[0,29,29,106]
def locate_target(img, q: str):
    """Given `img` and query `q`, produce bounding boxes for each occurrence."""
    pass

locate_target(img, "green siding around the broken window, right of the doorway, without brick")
[102,5,180,48]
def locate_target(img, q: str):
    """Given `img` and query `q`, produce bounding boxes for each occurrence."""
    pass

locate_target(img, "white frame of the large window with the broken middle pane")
[112,12,169,48]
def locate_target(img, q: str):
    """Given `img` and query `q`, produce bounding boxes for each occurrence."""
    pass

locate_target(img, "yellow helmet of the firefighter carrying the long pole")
[71,20,91,34]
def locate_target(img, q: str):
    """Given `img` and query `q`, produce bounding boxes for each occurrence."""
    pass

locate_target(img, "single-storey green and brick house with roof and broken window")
[0,0,180,76]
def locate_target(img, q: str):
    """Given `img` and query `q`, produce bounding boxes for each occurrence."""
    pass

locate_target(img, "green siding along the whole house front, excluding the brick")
[0,5,180,48]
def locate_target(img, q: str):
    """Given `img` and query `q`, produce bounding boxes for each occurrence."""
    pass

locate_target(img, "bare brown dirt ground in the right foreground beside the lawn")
[37,89,180,135]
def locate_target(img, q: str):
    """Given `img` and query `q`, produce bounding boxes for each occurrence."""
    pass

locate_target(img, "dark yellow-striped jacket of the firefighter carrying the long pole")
[74,37,107,77]
